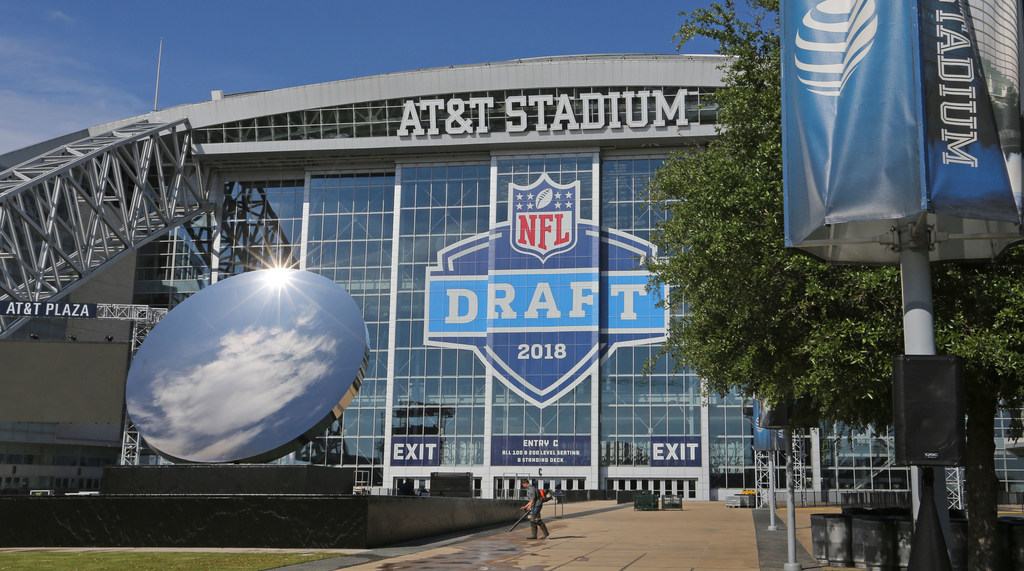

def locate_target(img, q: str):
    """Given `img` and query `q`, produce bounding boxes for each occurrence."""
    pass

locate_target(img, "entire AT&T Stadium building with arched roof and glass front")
[0,54,1024,499]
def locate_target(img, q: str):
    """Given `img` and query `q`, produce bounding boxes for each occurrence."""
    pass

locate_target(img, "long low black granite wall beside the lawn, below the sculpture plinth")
[0,495,522,548]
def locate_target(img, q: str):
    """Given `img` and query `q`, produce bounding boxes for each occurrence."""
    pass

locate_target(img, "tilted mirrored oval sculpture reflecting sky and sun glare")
[125,269,370,463]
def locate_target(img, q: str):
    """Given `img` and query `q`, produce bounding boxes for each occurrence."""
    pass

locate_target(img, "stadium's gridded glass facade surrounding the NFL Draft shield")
[134,151,1024,498]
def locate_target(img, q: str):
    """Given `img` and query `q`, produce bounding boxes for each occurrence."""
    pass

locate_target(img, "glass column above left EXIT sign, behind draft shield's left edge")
[388,163,490,467]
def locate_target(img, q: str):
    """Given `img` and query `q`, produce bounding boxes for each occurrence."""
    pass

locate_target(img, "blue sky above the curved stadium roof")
[0,0,715,153]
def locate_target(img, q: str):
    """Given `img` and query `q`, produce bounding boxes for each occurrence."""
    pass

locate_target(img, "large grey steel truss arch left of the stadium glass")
[0,120,213,339]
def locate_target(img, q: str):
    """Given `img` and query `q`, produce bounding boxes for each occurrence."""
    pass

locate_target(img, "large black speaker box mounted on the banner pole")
[893,355,967,466]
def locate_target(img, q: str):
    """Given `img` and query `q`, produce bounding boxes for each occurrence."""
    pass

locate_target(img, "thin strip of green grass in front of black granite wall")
[0,552,343,571]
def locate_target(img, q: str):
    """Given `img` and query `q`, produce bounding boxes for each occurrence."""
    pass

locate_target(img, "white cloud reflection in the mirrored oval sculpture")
[129,313,337,460]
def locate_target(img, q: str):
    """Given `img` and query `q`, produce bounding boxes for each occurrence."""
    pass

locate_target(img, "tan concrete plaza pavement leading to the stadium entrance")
[287,501,836,571]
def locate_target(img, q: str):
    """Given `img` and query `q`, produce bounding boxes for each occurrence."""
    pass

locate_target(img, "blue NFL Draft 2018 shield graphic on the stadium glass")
[424,174,668,407]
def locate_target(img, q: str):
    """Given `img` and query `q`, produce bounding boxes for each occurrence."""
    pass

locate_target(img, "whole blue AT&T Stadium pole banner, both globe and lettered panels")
[782,0,1020,261]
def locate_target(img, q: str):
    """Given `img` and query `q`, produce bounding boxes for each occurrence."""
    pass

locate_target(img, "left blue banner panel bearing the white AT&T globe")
[782,0,922,245]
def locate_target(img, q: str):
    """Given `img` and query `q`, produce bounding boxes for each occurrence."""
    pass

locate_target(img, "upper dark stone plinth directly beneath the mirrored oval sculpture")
[102,464,355,495]
